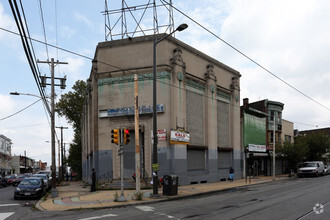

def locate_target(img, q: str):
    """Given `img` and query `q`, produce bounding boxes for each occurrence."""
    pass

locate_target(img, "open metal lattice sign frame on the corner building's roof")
[101,0,174,41]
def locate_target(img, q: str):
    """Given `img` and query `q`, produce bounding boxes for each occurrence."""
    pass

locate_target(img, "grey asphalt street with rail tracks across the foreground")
[0,175,330,220]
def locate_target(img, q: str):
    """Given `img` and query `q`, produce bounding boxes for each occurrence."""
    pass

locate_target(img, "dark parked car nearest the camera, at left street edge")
[14,177,45,199]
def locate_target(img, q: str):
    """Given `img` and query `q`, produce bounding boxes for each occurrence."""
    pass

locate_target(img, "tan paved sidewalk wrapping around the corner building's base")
[36,174,290,211]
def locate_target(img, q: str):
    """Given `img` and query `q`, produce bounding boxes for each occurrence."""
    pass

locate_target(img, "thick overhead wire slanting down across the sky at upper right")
[161,0,330,110]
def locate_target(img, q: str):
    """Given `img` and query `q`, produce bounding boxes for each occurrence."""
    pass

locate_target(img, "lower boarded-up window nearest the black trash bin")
[187,149,206,170]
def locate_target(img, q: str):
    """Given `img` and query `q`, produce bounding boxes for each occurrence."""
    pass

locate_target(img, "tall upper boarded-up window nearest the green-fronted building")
[217,100,231,148]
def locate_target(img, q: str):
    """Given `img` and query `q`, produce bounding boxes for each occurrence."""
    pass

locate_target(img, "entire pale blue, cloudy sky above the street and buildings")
[0,0,330,165]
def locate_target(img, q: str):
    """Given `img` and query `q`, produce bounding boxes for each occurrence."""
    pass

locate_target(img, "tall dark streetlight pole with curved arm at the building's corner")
[152,24,188,196]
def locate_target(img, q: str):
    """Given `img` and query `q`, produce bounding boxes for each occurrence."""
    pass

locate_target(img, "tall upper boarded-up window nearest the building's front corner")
[186,90,204,145]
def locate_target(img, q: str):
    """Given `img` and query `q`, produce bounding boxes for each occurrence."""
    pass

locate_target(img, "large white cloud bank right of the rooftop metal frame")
[179,0,330,129]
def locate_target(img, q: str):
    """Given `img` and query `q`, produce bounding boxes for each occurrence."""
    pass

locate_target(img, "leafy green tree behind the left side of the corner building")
[55,80,87,178]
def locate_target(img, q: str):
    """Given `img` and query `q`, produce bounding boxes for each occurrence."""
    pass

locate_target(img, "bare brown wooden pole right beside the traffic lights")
[134,74,141,192]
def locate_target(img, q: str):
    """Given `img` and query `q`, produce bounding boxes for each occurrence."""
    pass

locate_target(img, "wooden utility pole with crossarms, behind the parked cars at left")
[37,58,68,198]
